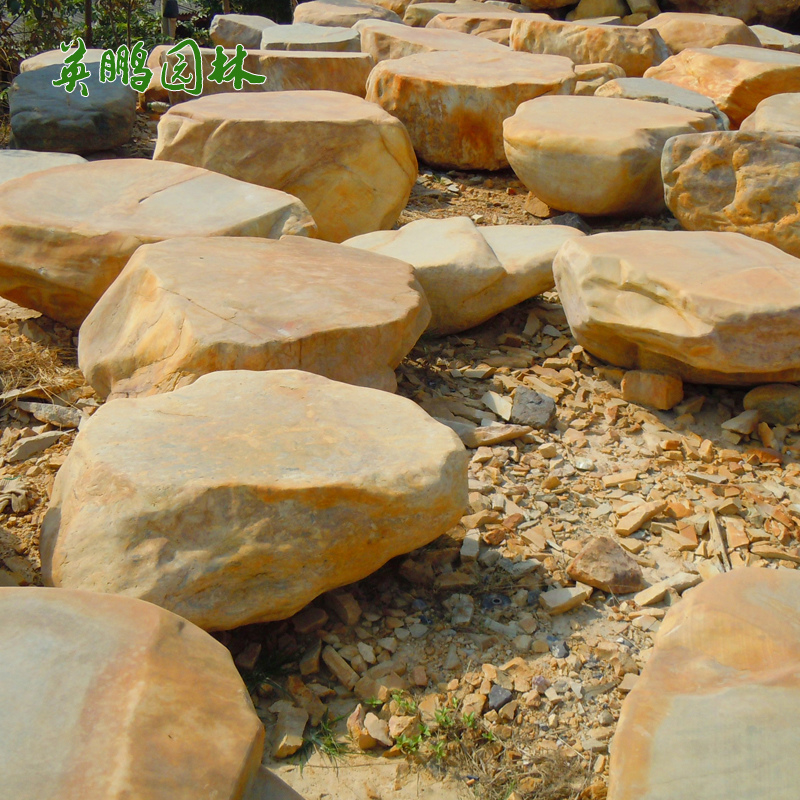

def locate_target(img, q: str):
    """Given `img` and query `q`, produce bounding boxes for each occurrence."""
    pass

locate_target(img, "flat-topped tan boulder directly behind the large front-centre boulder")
[78,236,430,397]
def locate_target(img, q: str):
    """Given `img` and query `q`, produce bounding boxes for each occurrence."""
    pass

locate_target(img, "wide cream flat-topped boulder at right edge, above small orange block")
[553,231,800,384]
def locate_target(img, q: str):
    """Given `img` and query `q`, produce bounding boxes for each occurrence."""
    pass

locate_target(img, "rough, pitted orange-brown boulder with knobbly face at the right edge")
[662,131,800,256]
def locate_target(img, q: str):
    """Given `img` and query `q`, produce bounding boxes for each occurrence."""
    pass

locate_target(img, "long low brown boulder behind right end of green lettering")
[167,47,374,105]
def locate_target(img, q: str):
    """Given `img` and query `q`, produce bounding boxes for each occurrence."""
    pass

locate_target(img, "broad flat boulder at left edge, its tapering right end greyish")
[0,159,316,328]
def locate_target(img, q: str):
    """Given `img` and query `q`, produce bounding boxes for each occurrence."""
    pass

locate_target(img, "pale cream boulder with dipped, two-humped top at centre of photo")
[345,217,583,335]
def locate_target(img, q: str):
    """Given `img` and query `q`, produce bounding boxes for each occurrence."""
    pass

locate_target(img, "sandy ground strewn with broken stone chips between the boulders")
[0,114,800,800]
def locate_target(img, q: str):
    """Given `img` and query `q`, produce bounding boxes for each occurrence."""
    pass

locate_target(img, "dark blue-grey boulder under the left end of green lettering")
[8,65,136,154]
